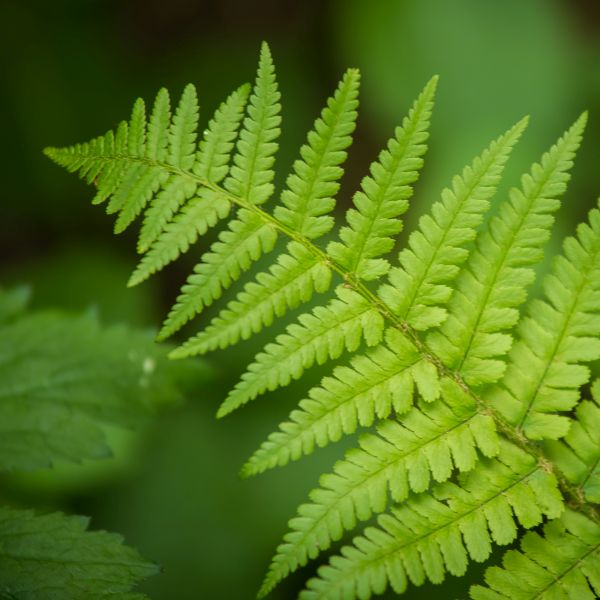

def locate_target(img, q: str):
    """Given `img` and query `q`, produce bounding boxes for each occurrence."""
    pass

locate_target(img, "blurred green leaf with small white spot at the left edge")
[0,313,192,470]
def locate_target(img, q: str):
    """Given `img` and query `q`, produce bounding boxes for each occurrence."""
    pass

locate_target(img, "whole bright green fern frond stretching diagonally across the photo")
[46,45,600,600]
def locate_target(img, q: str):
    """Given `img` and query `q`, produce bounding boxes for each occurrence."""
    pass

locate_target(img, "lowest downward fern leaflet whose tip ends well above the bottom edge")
[242,336,462,476]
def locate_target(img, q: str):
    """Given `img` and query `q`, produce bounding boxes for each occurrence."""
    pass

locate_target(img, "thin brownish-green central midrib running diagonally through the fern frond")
[57,150,600,525]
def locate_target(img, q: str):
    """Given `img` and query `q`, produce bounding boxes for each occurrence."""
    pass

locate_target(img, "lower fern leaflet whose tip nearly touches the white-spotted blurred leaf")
[172,242,331,358]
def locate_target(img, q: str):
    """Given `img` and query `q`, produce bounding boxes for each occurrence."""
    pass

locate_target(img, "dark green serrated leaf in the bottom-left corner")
[0,507,158,600]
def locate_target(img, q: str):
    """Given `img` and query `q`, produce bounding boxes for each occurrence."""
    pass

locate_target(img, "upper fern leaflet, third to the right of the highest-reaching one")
[378,119,527,330]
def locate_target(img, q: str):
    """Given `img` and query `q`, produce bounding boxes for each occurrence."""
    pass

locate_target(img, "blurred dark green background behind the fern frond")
[0,0,600,600]
